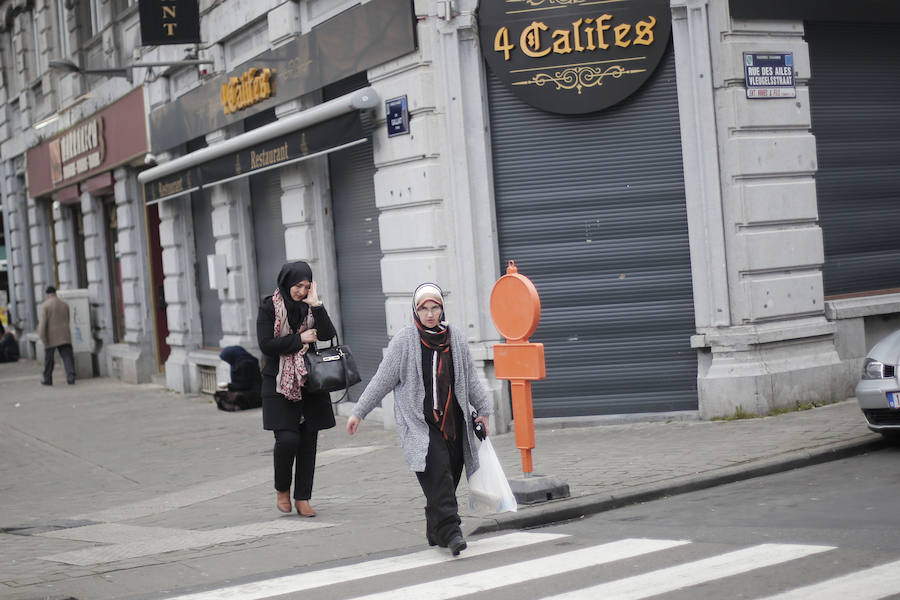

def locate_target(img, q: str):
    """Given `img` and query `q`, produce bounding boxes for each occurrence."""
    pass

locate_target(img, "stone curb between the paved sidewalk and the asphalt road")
[471,435,887,535]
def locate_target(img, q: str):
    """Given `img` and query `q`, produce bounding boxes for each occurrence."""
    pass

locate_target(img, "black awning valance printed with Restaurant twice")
[144,112,366,203]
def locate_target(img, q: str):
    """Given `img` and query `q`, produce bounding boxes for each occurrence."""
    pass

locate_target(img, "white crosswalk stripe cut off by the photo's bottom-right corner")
[761,561,900,600]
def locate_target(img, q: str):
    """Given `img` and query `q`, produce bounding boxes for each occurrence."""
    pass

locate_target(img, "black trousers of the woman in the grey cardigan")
[416,423,464,545]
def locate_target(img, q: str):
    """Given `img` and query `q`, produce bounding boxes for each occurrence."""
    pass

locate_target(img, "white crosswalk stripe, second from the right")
[544,544,834,600]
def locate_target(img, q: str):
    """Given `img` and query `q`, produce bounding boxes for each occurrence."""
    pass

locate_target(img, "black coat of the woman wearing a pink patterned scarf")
[256,296,336,431]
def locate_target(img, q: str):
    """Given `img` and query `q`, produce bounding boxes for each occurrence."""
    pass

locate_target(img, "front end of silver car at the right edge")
[856,330,900,438]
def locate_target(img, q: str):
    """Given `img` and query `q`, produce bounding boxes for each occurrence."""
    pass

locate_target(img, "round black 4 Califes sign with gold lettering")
[478,0,672,114]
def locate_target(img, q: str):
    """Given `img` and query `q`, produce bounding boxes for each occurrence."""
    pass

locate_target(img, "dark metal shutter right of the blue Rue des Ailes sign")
[805,22,900,295]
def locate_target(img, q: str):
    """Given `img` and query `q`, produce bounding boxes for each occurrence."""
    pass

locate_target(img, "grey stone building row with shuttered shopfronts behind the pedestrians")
[0,0,900,422]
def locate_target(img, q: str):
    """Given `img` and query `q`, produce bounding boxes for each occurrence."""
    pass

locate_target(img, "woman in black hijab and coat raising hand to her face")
[256,261,335,517]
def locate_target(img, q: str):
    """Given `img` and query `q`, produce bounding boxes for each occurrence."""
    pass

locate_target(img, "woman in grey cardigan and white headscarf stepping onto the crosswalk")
[347,283,492,556]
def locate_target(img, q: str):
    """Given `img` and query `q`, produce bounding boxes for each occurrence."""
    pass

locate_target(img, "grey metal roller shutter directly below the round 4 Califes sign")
[488,44,697,417]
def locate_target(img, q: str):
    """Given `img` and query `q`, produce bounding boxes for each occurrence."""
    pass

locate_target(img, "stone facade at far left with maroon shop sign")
[0,0,158,382]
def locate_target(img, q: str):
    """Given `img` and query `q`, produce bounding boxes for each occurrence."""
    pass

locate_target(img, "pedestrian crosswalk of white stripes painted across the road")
[156,532,900,600]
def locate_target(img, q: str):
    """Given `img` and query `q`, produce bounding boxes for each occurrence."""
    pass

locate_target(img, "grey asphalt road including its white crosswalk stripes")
[121,447,900,600]
